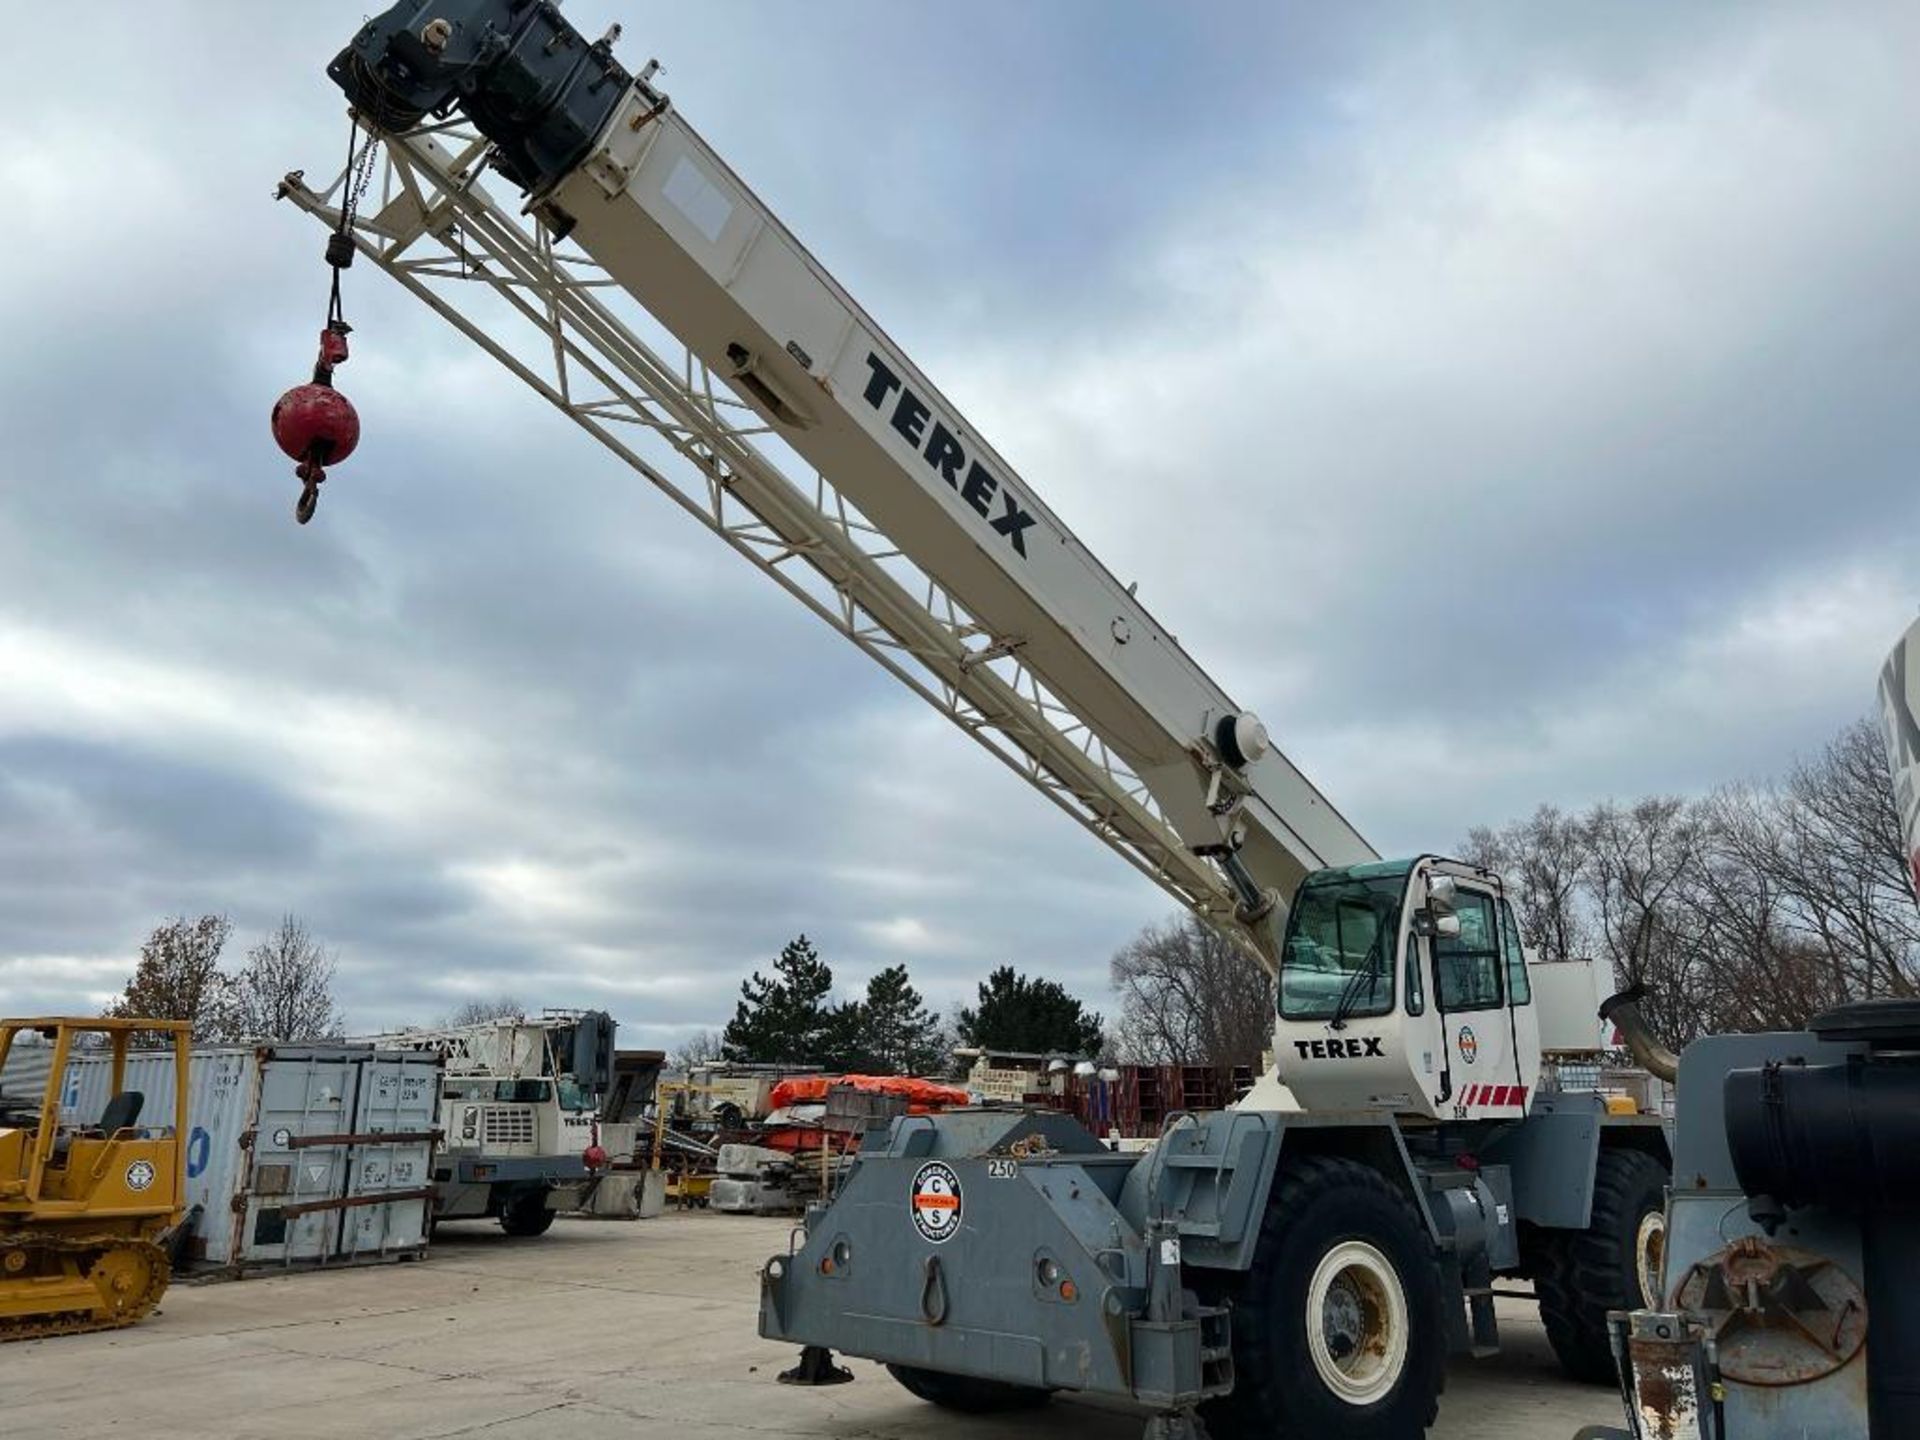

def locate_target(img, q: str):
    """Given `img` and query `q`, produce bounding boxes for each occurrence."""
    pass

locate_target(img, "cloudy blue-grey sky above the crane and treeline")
[0,0,1920,1044]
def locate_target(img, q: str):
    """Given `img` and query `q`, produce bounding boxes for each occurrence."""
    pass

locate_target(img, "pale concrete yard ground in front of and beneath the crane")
[0,1213,1619,1440]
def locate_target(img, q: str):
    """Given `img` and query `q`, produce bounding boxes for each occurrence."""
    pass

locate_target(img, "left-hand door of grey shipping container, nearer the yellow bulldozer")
[240,1048,365,1265]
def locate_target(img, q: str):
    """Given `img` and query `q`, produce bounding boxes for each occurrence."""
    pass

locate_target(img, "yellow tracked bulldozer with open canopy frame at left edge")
[0,1020,190,1340]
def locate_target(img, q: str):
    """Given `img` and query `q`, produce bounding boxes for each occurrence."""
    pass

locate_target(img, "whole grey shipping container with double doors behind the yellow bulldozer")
[61,1044,440,1269]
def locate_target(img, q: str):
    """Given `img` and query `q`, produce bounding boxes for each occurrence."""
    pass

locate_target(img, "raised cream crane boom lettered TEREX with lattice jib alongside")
[280,0,1375,966]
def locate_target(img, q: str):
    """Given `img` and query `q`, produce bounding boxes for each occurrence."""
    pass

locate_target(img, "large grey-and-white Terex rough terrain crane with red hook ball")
[276,0,1668,1440]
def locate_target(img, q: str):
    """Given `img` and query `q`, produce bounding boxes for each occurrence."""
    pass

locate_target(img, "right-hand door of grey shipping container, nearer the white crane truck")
[340,1050,440,1258]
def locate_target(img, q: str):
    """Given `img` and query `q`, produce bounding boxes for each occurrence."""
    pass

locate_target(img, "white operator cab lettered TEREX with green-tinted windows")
[1275,856,1540,1119]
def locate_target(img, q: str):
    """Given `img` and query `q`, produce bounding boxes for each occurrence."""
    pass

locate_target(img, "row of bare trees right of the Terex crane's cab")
[1463,720,1920,1048]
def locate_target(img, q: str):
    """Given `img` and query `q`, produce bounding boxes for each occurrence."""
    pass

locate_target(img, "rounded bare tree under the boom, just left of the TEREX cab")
[1112,916,1273,1066]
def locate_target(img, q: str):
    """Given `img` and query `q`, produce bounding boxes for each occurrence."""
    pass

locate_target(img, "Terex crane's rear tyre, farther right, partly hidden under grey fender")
[1534,1150,1668,1384]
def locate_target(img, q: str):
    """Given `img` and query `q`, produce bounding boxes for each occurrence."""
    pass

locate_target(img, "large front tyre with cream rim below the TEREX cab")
[1204,1156,1446,1440]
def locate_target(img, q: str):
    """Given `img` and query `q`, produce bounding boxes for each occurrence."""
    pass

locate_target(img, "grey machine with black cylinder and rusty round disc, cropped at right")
[1586,1000,1920,1440]
